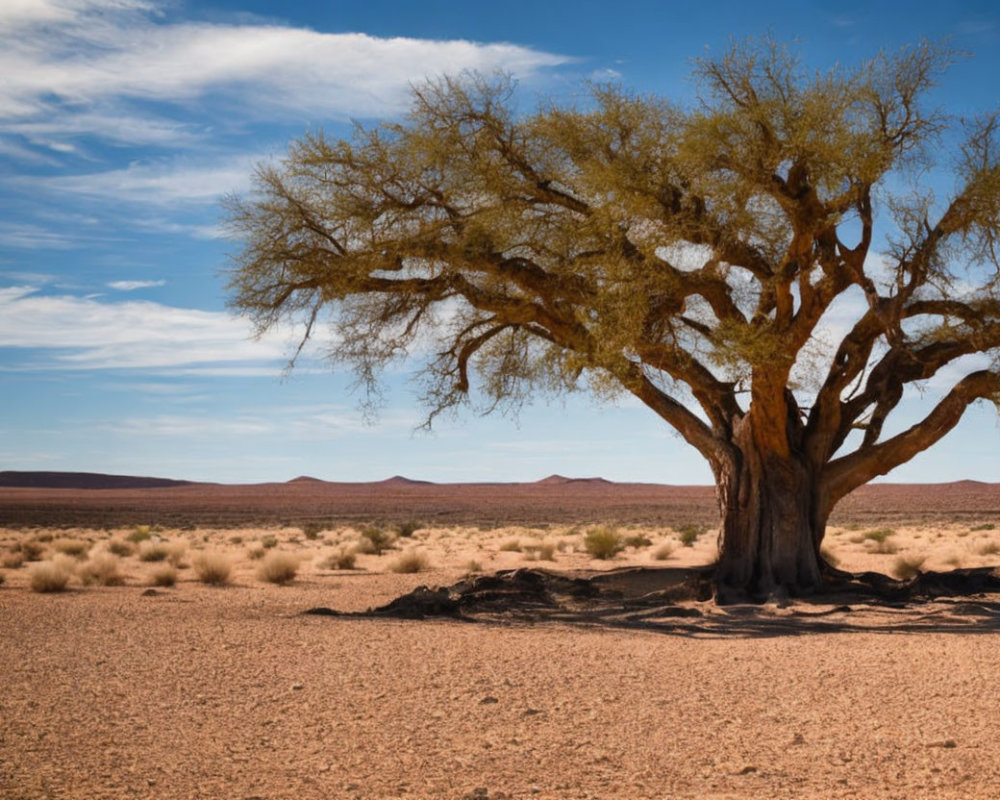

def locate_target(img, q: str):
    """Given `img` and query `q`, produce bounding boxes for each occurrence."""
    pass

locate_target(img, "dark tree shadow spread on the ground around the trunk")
[304,567,1000,639]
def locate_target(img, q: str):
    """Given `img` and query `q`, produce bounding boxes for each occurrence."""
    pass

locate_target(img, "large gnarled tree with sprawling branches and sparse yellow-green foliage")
[229,41,1000,598]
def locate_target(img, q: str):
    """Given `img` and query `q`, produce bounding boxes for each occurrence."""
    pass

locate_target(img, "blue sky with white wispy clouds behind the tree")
[0,0,1000,483]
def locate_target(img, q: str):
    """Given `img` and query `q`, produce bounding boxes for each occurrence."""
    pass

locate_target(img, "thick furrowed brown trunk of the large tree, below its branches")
[716,418,829,603]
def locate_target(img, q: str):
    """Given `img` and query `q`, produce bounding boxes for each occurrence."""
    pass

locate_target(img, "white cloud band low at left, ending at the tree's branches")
[0,286,312,374]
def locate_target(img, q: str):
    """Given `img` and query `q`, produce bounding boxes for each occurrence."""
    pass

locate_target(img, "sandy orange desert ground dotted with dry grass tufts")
[0,482,1000,800]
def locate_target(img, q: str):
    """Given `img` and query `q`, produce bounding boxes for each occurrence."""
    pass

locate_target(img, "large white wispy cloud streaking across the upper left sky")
[0,0,571,152]
